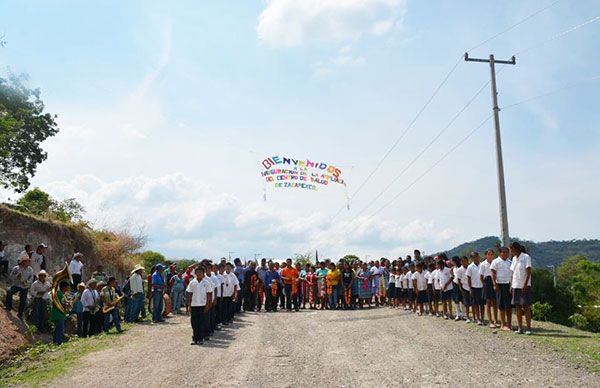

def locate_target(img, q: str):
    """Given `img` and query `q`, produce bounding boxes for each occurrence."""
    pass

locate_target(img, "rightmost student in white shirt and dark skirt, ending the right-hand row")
[510,241,532,334]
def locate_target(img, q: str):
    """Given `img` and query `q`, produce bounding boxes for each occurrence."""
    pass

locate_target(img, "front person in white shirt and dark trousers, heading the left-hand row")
[186,266,214,345]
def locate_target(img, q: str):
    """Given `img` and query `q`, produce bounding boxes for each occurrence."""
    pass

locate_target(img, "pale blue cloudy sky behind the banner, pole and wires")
[0,0,600,257]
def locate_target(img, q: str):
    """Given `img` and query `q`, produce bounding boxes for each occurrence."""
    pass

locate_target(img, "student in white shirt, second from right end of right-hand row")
[490,247,512,331]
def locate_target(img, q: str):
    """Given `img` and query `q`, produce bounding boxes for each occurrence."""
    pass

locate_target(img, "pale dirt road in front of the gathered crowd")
[51,308,600,387]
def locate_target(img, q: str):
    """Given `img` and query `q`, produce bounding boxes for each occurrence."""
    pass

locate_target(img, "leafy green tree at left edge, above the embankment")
[0,74,59,193]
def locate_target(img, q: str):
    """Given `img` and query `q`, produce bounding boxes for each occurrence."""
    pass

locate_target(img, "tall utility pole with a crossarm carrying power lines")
[465,53,517,247]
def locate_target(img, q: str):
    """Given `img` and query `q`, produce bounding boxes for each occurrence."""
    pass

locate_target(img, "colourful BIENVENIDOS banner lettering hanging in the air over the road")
[261,156,346,191]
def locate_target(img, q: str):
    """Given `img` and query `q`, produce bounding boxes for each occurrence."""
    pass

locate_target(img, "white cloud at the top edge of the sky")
[256,0,406,47]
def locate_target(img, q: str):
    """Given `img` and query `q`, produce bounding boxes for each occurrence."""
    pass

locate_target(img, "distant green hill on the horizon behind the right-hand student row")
[446,236,600,268]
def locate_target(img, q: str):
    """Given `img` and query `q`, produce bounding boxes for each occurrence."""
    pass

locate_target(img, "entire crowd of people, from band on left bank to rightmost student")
[0,242,531,345]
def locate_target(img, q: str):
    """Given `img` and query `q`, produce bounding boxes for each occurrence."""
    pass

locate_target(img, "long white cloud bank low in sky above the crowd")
[42,173,451,257]
